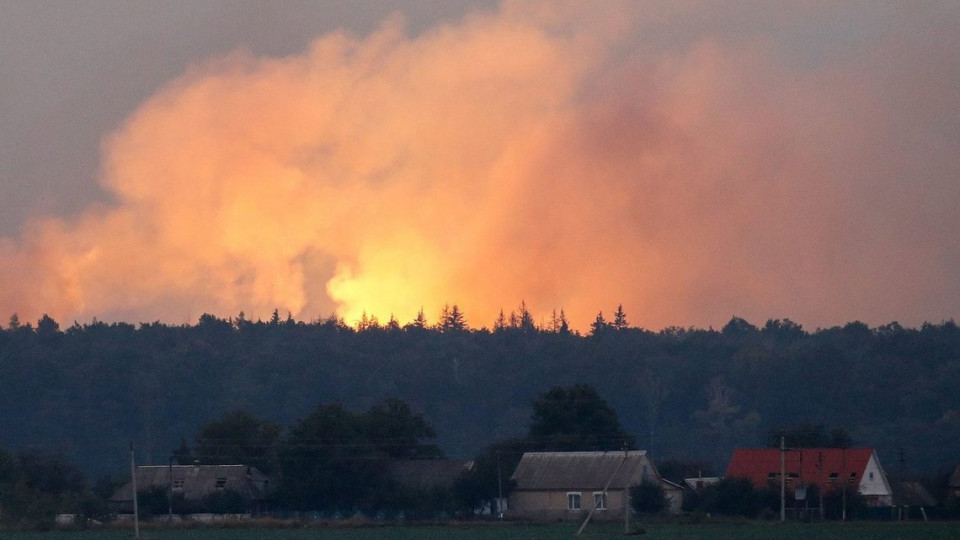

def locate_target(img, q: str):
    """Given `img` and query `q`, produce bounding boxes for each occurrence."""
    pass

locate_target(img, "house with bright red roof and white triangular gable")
[726,448,893,506]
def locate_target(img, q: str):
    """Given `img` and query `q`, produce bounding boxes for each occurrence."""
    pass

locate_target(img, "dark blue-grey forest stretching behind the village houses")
[0,304,960,484]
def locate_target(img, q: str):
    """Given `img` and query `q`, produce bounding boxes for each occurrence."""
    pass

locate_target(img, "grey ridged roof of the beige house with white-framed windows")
[512,450,660,490]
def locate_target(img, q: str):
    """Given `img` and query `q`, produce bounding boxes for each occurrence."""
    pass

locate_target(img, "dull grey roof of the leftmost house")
[110,465,269,502]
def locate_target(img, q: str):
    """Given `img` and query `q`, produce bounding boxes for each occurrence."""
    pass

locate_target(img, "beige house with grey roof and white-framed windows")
[508,451,683,521]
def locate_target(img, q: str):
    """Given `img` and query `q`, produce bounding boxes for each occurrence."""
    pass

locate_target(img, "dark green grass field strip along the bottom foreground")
[0,522,960,540]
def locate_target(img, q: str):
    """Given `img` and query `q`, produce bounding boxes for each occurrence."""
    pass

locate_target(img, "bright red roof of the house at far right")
[726,448,873,486]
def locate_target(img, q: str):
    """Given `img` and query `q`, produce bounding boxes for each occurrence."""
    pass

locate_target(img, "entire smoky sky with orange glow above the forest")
[0,0,960,329]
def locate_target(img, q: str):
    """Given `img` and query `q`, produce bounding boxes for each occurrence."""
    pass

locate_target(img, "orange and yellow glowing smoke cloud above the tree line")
[0,2,960,329]
